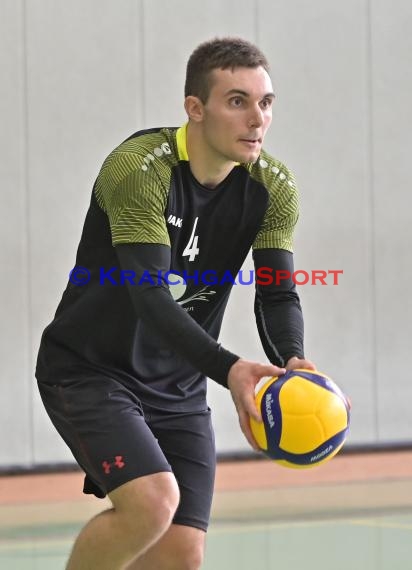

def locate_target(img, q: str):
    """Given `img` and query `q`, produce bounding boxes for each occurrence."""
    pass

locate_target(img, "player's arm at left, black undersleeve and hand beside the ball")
[116,244,285,450]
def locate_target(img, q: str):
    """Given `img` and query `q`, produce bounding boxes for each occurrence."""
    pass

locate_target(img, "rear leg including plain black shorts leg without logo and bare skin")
[127,410,215,570]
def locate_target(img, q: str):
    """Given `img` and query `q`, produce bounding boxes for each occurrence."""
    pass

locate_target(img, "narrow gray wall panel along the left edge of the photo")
[0,0,32,467]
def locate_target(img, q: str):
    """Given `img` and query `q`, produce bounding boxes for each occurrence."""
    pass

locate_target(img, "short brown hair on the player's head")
[185,37,269,103]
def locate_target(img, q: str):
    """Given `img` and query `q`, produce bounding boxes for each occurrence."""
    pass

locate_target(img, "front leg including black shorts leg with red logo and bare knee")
[39,376,179,570]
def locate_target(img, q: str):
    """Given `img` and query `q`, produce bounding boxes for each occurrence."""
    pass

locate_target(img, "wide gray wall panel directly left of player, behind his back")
[28,0,145,462]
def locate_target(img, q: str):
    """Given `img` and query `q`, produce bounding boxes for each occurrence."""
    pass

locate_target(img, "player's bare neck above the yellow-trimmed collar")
[186,122,237,188]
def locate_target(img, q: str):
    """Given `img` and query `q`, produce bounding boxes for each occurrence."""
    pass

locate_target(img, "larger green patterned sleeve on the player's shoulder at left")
[95,152,170,245]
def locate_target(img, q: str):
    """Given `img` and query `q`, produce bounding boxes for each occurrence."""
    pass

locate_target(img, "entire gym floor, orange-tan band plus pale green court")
[0,451,412,570]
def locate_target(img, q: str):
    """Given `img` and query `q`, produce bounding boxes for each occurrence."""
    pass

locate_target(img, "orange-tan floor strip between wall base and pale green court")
[0,451,412,524]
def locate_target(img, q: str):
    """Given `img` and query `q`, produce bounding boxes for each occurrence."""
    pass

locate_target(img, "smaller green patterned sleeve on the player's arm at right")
[253,163,299,252]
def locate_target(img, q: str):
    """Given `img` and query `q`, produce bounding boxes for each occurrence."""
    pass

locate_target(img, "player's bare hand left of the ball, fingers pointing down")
[227,358,286,451]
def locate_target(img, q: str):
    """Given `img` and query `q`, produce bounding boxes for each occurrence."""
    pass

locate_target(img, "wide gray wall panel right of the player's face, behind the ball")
[259,0,377,442]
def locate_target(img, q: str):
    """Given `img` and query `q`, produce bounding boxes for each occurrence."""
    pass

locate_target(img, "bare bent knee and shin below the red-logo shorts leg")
[67,473,179,570]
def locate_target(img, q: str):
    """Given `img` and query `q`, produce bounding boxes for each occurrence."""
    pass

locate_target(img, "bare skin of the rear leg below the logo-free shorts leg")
[127,524,206,570]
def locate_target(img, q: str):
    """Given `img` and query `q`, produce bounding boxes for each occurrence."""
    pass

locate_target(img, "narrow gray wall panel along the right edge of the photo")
[371,0,412,442]
